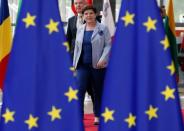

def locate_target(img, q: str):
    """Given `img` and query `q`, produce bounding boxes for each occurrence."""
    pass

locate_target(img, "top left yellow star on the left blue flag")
[22,12,36,28]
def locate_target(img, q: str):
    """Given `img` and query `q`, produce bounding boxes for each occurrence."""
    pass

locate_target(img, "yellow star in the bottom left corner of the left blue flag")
[2,108,15,123]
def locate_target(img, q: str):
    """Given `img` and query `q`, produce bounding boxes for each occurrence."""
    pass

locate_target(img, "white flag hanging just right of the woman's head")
[101,0,115,37]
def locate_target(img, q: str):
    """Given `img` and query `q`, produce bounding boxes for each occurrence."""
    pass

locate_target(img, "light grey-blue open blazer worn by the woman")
[73,22,111,69]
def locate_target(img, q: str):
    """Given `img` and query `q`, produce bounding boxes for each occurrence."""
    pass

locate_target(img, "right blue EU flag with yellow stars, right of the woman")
[99,0,184,131]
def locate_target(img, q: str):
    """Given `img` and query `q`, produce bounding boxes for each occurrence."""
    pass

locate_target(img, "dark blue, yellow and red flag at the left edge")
[0,0,12,89]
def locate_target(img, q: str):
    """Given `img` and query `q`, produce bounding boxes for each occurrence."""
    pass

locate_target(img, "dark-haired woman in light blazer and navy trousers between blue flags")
[73,6,111,124]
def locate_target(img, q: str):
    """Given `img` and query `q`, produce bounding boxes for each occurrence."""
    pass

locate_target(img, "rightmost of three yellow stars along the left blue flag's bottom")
[48,106,61,121]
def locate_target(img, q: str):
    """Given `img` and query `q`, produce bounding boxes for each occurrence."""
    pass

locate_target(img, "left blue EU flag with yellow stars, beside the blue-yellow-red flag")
[0,0,83,131]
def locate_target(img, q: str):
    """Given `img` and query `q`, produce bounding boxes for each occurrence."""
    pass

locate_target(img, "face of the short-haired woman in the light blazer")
[84,9,96,23]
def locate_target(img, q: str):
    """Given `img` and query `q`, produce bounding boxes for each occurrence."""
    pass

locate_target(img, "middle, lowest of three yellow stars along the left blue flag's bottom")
[25,114,38,130]
